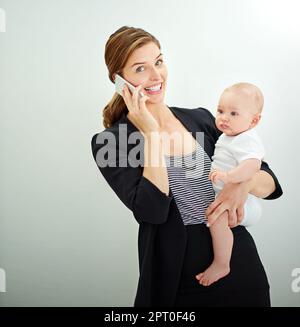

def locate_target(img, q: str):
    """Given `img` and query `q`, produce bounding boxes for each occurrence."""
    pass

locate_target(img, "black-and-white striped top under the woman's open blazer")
[165,141,215,225]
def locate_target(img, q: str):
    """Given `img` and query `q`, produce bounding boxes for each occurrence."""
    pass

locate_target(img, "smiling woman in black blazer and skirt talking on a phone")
[92,26,282,307]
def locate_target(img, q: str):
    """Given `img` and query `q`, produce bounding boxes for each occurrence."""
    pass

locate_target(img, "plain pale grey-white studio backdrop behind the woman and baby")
[0,0,300,306]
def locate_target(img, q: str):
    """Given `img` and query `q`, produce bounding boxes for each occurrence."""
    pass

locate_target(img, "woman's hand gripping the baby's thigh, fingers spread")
[206,182,250,227]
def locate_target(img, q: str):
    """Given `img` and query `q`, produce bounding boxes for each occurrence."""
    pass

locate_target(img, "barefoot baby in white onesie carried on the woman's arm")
[198,83,265,286]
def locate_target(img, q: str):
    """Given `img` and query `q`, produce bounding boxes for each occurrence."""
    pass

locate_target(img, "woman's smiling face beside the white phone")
[122,42,168,104]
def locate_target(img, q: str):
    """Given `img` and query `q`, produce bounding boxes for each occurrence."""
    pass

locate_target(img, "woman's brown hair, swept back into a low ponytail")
[103,26,160,128]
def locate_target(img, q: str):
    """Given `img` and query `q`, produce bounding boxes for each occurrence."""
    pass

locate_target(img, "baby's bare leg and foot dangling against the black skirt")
[197,211,233,286]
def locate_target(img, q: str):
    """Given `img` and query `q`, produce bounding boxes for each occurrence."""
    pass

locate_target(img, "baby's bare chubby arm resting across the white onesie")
[209,159,261,184]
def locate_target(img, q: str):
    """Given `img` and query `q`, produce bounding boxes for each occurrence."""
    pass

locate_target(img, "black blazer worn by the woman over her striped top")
[91,107,282,307]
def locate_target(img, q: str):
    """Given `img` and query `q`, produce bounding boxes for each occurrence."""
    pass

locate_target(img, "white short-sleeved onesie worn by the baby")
[211,128,265,226]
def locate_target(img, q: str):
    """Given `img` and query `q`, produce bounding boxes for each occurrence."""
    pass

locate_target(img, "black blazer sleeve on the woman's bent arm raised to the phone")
[91,134,173,224]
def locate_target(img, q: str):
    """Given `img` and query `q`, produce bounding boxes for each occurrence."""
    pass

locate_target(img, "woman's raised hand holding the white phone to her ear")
[123,85,159,135]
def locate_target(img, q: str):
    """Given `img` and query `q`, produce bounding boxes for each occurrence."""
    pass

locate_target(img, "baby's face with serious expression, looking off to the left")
[216,91,260,136]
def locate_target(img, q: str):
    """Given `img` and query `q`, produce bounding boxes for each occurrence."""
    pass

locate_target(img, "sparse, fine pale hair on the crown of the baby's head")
[223,83,264,113]
